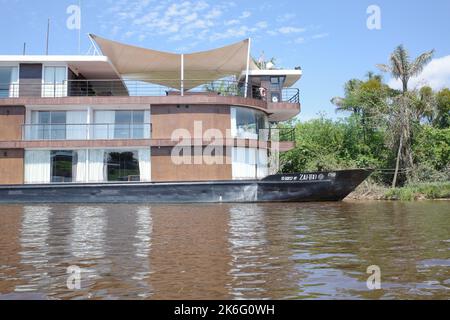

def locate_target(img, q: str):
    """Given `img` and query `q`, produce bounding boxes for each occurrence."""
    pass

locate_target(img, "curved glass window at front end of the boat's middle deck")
[231,107,269,139]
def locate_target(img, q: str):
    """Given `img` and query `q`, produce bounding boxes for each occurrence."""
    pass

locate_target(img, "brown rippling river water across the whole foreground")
[0,201,450,299]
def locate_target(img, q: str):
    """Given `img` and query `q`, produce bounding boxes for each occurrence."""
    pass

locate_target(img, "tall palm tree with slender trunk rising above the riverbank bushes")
[377,45,434,188]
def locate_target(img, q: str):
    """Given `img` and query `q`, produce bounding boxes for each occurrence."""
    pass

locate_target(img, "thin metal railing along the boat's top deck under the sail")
[0,79,300,103]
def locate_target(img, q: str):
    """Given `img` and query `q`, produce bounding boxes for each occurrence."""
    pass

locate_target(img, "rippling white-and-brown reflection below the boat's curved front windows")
[229,204,296,299]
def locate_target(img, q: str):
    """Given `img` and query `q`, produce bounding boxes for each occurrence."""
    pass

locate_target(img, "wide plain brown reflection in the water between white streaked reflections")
[148,205,230,299]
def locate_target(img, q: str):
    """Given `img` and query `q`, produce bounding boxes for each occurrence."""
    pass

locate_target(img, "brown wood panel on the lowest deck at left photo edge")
[0,149,24,184]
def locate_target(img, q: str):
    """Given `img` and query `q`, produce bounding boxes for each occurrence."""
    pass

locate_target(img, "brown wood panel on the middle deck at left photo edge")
[0,106,25,141]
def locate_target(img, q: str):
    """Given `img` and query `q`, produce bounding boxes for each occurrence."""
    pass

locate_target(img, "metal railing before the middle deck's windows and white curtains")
[22,123,152,141]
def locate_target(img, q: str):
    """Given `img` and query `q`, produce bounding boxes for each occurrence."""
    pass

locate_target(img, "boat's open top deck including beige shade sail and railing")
[0,36,301,121]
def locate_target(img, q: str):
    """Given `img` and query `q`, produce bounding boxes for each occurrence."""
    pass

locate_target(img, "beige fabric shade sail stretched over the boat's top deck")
[90,35,258,90]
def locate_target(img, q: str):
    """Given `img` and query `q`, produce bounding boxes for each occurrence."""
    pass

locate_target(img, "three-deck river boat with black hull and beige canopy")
[0,35,370,203]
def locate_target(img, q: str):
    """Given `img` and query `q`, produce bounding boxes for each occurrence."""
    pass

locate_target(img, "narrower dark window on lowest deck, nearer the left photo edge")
[50,150,77,183]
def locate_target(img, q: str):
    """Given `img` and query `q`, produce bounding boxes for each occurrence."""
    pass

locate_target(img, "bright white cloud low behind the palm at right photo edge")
[388,55,450,90]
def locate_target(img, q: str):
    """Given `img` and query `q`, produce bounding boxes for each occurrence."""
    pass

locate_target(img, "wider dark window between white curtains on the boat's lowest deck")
[106,151,140,181]
